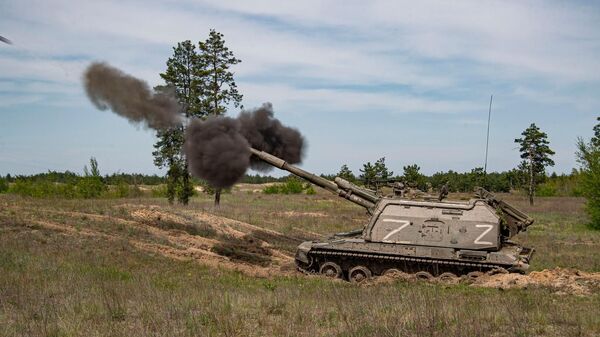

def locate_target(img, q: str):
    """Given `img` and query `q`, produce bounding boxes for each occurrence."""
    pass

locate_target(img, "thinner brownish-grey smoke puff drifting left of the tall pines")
[84,62,181,129]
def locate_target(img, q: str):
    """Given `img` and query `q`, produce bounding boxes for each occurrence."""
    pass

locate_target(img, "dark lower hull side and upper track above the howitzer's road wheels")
[296,249,511,278]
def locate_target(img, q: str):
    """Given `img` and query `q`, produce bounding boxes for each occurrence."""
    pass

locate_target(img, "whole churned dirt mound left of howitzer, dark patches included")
[15,204,302,277]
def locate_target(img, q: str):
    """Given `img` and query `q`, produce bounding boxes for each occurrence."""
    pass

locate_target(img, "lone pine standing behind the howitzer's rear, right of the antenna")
[515,123,554,205]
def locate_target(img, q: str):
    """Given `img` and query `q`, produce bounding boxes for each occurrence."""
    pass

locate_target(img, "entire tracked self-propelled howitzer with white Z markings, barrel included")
[251,149,533,282]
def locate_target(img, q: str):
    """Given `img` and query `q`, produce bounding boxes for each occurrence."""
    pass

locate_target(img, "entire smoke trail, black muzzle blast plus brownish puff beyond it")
[84,63,304,188]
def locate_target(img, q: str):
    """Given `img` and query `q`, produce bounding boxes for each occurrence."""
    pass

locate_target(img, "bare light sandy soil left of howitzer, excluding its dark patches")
[17,205,295,277]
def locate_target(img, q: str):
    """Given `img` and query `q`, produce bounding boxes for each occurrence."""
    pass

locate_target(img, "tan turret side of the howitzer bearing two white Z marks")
[364,199,501,251]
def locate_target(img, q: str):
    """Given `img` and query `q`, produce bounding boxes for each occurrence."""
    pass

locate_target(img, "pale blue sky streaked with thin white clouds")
[0,0,600,175]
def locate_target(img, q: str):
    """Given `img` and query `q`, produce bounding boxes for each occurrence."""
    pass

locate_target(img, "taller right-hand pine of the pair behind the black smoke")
[198,29,242,206]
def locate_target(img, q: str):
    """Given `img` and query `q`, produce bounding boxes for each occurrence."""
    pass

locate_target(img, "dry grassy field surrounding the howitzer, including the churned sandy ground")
[0,188,600,336]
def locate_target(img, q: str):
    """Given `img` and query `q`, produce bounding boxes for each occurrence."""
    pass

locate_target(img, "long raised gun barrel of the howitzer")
[250,148,379,213]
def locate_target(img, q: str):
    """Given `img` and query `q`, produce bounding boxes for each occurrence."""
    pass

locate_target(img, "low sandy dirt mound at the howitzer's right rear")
[472,268,600,296]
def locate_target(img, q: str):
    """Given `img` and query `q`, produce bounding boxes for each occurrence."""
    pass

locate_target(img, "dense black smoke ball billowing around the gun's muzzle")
[184,103,304,188]
